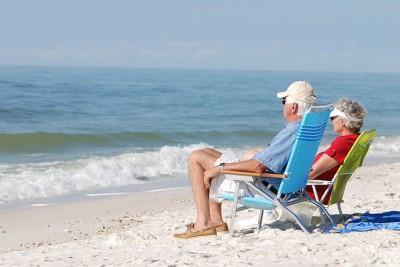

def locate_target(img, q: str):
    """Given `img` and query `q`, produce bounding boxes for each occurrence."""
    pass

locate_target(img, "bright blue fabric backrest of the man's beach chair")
[278,105,332,195]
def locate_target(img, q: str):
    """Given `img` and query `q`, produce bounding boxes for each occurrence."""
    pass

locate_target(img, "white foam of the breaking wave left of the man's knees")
[0,144,244,203]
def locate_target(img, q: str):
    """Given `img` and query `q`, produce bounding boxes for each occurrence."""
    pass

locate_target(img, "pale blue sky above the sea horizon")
[0,0,400,73]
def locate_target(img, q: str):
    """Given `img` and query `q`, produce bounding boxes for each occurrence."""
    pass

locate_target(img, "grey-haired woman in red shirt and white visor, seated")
[306,98,366,204]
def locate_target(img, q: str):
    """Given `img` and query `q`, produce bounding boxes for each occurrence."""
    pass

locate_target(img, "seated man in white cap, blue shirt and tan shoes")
[174,81,316,239]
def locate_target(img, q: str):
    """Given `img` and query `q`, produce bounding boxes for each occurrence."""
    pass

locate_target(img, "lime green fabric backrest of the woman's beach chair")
[328,129,376,205]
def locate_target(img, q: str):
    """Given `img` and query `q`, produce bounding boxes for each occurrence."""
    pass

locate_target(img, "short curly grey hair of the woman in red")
[333,98,367,133]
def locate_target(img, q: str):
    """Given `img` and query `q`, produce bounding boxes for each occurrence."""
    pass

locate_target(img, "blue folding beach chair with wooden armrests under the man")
[219,105,334,236]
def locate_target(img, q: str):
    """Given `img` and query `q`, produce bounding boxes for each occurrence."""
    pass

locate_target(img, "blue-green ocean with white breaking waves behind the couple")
[0,66,400,208]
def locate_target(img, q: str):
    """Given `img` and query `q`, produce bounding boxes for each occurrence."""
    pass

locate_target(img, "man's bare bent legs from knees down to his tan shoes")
[188,148,222,230]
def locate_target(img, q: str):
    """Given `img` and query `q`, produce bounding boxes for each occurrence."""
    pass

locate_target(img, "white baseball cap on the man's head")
[276,81,316,104]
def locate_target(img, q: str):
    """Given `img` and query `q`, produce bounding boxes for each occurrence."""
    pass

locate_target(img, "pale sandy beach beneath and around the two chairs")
[0,163,400,266]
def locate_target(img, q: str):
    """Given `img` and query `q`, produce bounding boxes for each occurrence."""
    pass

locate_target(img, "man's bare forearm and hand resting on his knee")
[204,159,267,188]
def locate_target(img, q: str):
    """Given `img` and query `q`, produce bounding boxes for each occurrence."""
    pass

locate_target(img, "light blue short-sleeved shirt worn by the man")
[254,120,301,173]
